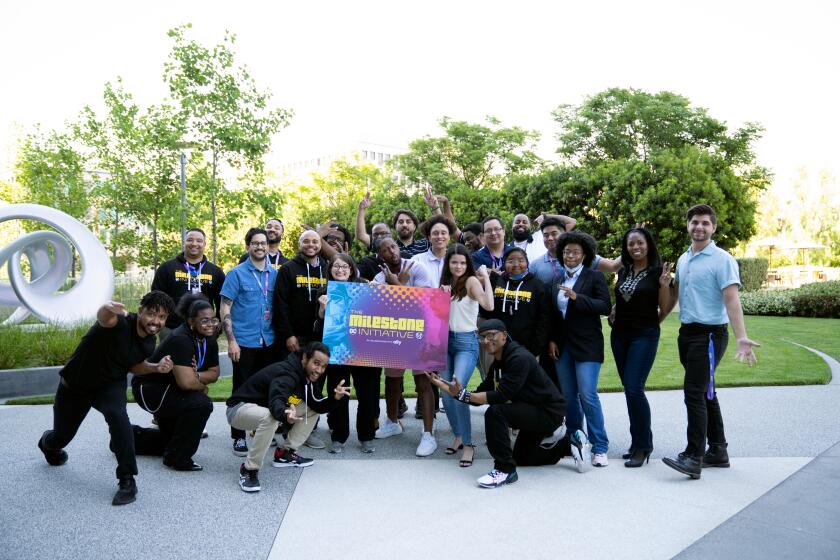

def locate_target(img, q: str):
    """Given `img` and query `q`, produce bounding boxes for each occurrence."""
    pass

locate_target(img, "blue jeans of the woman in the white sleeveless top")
[440,331,478,445]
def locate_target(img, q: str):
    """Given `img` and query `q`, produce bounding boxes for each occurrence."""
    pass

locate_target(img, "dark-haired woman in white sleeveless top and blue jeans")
[440,243,493,467]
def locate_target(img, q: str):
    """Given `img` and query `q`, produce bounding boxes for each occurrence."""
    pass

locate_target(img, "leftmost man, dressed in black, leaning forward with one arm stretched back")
[38,291,174,506]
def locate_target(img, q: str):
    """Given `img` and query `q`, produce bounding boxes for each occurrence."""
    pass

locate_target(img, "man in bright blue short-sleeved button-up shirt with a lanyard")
[221,228,278,457]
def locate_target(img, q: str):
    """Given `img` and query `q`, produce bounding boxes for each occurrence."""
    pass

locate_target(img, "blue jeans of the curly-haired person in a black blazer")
[554,350,610,453]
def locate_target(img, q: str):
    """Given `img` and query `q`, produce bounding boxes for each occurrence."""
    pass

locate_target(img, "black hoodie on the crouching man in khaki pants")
[266,352,338,422]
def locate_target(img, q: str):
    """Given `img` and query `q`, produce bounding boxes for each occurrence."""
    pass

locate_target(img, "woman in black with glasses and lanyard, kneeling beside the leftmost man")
[131,294,219,471]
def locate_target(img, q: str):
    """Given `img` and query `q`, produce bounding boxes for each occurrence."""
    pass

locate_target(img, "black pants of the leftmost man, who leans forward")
[42,380,137,478]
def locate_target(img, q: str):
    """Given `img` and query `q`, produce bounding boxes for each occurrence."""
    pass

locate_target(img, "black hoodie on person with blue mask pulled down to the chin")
[481,272,551,356]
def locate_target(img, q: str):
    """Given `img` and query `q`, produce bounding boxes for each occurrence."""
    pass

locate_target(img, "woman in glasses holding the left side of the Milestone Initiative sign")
[315,253,382,453]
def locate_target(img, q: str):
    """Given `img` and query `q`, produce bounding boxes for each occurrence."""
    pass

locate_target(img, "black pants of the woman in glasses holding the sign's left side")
[326,364,382,443]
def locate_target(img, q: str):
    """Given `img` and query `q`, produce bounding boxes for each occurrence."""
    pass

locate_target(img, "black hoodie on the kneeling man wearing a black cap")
[476,340,566,416]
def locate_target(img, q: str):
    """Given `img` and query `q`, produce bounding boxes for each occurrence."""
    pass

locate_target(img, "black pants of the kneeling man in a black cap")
[484,402,568,473]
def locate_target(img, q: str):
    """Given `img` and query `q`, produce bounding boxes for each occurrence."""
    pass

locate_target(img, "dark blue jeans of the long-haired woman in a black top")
[610,328,659,451]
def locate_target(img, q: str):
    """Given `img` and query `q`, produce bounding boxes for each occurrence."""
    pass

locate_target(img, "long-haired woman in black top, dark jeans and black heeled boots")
[610,227,671,468]
